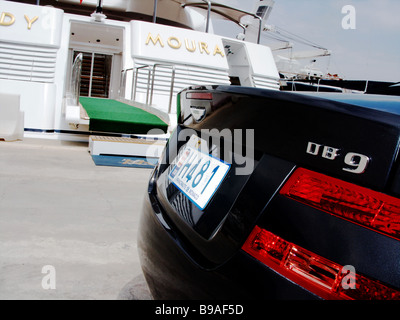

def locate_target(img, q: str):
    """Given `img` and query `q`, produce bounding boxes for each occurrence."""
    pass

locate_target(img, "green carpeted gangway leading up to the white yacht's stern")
[79,97,168,134]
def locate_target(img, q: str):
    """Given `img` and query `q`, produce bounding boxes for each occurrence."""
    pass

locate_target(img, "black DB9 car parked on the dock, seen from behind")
[138,86,400,300]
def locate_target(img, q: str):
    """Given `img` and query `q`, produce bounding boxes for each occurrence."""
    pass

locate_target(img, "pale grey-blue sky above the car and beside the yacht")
[215,0,400,82]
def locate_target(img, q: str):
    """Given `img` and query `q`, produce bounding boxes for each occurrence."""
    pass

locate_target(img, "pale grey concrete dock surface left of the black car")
[0,138,151,300]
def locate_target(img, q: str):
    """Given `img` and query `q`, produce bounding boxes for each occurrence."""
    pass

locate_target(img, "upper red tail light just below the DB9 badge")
[280,168,400,239]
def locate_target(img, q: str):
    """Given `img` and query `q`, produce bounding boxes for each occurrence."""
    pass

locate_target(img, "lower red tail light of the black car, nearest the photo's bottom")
[242,226,400,300]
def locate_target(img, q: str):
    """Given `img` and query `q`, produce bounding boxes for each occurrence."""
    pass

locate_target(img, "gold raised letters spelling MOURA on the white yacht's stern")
[146,32,225,57]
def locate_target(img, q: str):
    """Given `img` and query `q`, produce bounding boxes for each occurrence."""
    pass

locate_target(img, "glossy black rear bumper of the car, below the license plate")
[138,190,318,300]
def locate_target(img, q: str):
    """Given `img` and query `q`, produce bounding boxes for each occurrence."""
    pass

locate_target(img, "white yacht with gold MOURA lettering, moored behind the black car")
[0,0,279,159]
